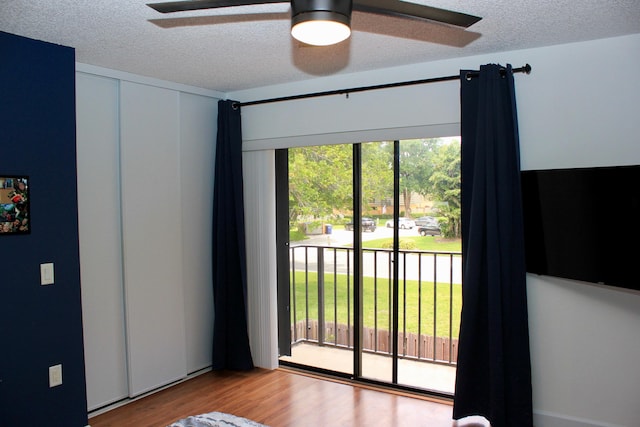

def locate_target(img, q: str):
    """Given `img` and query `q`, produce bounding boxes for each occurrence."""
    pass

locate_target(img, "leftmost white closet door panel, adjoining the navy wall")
[76,73,129,411]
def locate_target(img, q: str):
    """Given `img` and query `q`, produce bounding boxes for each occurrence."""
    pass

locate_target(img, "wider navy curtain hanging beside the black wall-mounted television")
[453,65,533,427]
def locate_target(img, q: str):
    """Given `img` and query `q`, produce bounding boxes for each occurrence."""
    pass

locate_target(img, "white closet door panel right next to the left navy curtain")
[180,93,218,373]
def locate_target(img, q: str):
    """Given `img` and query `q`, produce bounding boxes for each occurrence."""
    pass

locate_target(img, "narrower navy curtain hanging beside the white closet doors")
[212,101,253,370]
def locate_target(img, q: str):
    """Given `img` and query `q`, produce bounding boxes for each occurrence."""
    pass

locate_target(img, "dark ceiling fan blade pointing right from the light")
[353,0,482,28]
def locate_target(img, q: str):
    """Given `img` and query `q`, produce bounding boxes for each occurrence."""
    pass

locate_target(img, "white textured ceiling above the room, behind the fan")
[0,0,640,92]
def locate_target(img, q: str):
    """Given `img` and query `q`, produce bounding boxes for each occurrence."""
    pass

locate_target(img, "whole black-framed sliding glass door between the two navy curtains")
[277,139,461,394]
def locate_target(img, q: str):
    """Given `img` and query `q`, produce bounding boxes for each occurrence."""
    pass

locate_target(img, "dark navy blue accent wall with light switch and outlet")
[0,32,87,427]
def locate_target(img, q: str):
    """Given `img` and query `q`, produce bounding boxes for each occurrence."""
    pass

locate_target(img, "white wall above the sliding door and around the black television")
[229,35,640,427]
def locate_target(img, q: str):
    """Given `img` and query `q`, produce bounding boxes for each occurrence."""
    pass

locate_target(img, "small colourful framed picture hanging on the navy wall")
[0,174,31,236]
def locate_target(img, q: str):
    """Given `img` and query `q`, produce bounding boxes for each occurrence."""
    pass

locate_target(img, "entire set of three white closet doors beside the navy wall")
[76,64,222,410]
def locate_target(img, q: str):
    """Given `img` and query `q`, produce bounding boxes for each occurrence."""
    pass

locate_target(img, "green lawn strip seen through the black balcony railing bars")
[291,272,462,338]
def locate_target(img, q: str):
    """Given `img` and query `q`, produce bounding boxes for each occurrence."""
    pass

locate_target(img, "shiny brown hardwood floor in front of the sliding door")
[89,369,457,427]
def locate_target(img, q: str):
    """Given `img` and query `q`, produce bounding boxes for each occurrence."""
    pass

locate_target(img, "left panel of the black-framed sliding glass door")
[277,145,355,376]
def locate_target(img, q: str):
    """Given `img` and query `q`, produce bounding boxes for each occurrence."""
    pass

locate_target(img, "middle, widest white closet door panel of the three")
[120,82,187,397]
